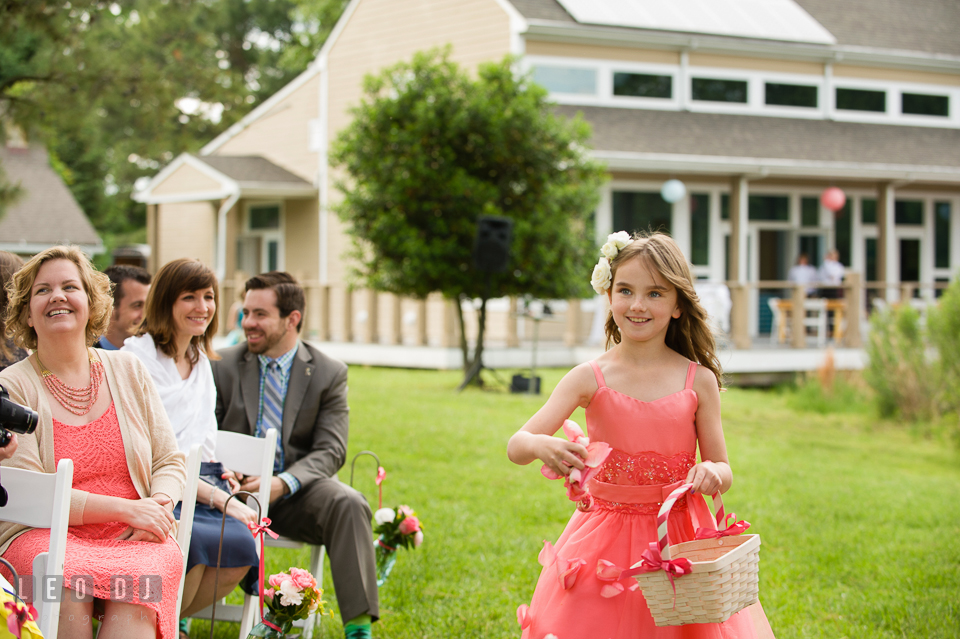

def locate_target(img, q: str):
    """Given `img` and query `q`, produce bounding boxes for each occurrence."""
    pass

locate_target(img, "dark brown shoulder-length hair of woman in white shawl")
[137,258,220,364]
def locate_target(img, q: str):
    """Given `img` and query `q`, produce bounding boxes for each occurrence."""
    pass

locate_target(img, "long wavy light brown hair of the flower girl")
[604,233,723,389]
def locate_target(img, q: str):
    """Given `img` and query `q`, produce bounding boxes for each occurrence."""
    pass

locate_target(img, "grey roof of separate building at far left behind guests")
[0,146,104,255]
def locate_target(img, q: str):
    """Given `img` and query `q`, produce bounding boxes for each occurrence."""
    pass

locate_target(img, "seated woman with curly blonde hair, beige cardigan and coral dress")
[0,246,186,639]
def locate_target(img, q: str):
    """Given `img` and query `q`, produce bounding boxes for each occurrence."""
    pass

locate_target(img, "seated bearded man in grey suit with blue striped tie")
[212,271,379,639]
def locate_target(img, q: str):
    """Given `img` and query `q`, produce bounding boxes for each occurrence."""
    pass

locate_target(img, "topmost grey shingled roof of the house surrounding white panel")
[509,0,960,57]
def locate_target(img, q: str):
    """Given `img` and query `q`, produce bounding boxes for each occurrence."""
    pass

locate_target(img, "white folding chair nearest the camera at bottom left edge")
[0,459,73,637]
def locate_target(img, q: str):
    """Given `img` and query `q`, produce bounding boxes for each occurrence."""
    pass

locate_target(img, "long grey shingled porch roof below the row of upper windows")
[555,106,960,184]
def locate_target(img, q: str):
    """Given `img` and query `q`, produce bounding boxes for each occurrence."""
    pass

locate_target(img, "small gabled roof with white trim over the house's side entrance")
[133,153,317,204]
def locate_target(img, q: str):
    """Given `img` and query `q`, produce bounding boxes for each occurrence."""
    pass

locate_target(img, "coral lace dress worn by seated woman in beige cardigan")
[3,404,183,639]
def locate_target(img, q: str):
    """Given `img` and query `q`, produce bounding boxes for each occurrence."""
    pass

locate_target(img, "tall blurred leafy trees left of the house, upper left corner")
[0,0,346,260]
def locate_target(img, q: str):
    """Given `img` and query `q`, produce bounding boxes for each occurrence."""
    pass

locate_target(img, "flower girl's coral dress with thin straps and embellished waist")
[523,362,772,639]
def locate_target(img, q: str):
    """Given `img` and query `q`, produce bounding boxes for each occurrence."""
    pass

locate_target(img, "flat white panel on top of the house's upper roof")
[558,0,836,44]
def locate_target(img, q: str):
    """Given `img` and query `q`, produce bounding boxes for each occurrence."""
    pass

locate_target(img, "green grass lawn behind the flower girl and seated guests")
[184,367,960,639]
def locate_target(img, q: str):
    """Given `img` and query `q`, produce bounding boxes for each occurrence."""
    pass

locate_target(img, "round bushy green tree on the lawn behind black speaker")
[331,51,604,383]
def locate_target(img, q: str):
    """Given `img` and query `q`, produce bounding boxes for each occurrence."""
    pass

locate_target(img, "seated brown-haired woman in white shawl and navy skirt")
[121,259,259,633]
